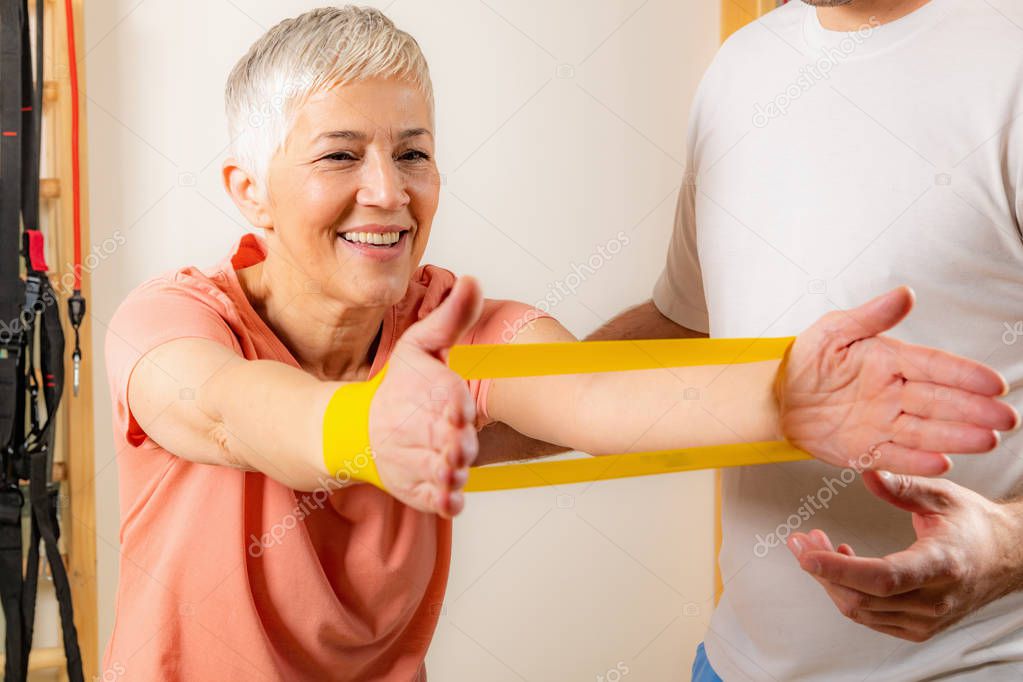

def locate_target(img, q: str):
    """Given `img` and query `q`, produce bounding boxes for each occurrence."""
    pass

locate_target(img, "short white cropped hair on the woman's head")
[224,5,434,187]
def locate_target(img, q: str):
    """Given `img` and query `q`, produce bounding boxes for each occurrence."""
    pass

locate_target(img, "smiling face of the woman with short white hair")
[267,79,440,307]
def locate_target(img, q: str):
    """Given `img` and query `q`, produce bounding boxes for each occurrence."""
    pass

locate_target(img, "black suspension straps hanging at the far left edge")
[0,0,83,682]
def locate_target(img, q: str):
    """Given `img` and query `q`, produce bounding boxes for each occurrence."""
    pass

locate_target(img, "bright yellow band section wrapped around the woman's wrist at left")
[323,365,387,490]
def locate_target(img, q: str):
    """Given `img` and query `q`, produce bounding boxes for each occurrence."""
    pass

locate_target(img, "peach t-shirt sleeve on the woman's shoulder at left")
[104,282,240,447]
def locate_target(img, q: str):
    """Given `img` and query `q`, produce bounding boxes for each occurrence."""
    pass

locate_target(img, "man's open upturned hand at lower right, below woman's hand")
[788,471,1023,642]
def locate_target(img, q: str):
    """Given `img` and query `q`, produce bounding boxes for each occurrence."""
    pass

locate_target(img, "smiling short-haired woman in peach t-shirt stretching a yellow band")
[105,7,1017,680]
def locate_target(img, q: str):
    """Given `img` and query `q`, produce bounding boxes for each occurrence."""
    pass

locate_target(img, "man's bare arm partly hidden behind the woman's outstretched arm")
[477,300,707,464]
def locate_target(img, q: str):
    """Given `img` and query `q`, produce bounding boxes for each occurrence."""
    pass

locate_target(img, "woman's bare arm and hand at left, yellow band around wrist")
[128,278,482,515]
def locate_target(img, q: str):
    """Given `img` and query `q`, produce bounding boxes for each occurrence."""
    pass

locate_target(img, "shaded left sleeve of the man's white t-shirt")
[653,77,710,333]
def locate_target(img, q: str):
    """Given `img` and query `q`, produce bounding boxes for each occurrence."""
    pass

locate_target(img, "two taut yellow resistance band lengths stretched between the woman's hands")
[448,337,810,493]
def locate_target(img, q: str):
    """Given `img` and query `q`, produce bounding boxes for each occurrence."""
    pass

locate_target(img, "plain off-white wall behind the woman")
[85,0,719,682]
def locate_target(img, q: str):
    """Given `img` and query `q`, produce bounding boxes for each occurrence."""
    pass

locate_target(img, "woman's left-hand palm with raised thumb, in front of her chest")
[369,277,483,517]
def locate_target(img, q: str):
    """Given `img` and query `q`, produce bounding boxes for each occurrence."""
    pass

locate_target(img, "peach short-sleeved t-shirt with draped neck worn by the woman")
[104,234,541,682]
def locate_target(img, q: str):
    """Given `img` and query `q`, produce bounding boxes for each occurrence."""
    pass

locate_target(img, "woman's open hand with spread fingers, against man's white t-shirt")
[777,286,1019,475]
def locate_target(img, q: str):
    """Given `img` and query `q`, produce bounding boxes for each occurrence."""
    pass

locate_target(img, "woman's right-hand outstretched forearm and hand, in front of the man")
[487,287,1019,475]
